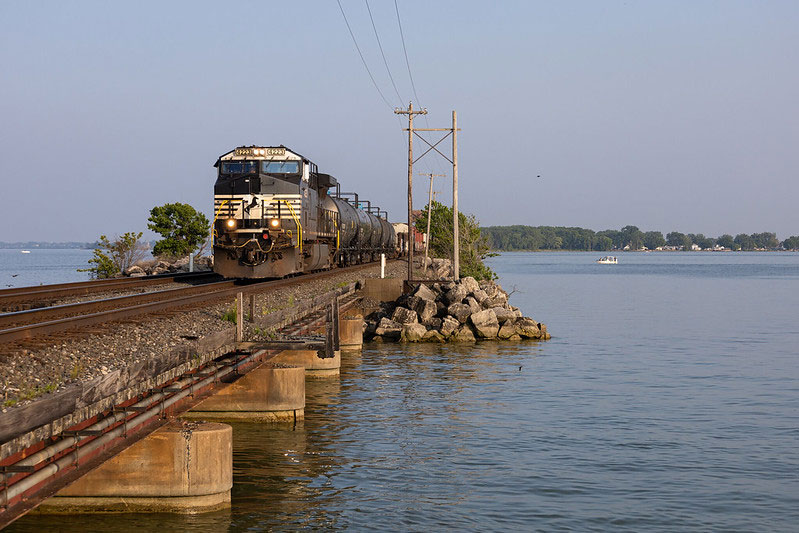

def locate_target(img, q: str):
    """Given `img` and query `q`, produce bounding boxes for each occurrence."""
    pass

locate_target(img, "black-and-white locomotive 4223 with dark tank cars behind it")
[213,145,397,278]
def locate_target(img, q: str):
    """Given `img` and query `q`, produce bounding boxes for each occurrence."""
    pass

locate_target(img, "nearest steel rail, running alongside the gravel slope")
[0,263,390,343]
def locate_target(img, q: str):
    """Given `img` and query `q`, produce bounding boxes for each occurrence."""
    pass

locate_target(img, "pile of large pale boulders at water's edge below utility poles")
[364,277,550,342]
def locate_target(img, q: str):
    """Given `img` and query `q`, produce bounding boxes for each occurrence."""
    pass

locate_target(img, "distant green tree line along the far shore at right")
[480,226,799,251]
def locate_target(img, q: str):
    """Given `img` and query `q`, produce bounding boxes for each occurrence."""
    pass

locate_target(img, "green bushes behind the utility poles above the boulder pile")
[416,201,497,280]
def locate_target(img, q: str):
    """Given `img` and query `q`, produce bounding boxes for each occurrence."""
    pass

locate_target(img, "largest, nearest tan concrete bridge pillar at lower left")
[36,421,233,514]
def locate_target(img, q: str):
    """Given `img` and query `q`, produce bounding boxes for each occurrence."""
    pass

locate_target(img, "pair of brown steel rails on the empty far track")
[0,272,218,307]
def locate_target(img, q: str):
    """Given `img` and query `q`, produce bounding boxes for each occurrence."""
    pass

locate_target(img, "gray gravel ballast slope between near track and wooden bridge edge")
[0,261,400,412]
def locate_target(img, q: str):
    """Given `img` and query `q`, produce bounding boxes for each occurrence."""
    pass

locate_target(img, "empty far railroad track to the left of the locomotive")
[0,272,222,311]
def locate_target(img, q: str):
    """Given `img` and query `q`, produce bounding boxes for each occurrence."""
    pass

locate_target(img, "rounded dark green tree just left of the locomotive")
[147,203,210,257]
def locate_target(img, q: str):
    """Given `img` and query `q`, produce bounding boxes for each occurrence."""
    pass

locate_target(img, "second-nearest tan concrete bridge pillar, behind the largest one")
[182,361,305,422]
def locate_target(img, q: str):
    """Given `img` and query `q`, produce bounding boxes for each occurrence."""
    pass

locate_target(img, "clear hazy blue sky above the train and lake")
[0,0,799,241]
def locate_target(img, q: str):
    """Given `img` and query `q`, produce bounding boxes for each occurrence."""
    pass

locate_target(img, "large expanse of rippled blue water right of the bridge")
[7,253,799,531]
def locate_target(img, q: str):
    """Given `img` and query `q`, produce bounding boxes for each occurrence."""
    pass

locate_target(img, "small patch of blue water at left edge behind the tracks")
[0,248,94,289]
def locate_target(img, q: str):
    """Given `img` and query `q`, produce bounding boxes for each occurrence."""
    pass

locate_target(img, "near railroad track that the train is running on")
[0,263,392,344]
